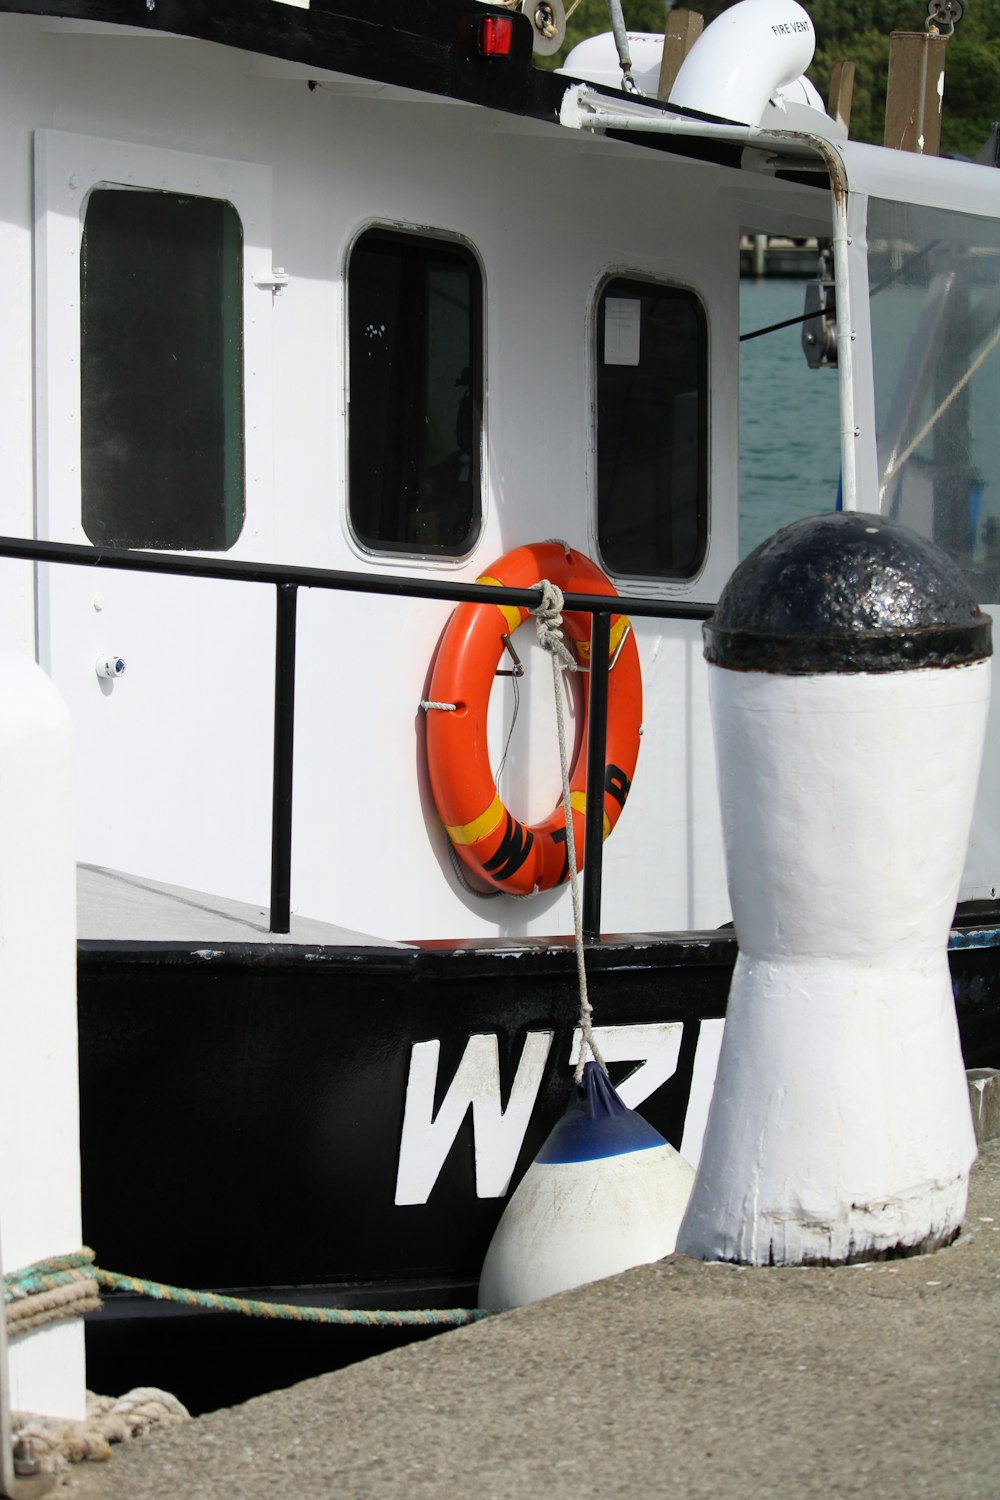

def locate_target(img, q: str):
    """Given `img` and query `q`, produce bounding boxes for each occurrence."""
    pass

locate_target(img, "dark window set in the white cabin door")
[79,188,244,552]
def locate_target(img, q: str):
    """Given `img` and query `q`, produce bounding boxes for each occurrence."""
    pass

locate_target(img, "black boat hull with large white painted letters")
[79,926,1000,1409]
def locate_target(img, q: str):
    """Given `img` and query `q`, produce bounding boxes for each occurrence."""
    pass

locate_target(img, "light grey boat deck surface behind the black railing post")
[76,864,408,948]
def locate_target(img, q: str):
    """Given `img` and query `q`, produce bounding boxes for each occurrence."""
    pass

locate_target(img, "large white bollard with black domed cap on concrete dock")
[678,512,991,1265]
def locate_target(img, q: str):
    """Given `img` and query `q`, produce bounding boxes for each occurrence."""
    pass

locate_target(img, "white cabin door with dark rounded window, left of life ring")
[34,131,274,902]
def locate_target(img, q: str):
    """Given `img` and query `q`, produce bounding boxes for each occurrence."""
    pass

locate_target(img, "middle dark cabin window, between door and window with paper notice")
[348,230,483,557]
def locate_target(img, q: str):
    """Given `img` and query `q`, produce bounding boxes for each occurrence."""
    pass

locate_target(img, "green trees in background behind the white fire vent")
[546,0,1000,156]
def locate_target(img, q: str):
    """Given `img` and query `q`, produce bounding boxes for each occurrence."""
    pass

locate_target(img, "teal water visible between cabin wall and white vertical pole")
[739,281,840,558]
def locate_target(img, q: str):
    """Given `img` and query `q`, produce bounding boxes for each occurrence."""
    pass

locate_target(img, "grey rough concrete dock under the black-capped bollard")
[60,1140,1000,1500]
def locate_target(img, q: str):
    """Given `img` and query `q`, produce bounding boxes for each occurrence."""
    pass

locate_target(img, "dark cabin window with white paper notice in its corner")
[597,279,708,578]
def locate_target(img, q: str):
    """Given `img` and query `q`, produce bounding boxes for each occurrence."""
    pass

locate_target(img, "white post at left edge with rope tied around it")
[0,651,85,1419]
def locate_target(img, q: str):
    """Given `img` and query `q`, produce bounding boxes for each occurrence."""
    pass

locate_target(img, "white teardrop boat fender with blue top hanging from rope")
[480,1062,694,1311]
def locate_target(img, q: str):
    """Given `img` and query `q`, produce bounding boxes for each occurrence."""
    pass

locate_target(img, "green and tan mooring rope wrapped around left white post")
[3,1247,489,1338]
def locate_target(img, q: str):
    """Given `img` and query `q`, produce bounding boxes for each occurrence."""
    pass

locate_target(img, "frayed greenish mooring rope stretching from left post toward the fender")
[3,1250,489,1328]
